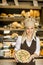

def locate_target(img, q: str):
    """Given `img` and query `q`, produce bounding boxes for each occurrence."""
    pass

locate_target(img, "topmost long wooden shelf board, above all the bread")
[0,5,41,10]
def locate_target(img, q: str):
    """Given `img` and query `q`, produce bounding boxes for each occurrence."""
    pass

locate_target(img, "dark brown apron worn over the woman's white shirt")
[17,40,36,65]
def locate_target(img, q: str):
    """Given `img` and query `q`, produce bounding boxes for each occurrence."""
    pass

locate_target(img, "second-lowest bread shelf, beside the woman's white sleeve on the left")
[0,39,16,50]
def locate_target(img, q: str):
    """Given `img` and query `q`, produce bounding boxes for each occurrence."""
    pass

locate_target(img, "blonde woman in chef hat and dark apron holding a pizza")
[15,18,40,65]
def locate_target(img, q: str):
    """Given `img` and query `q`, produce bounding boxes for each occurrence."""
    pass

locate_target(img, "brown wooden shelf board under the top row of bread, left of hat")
[0,16,24,22]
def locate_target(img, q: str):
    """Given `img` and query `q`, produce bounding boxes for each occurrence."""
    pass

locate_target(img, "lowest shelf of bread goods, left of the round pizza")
[0,49,15,58]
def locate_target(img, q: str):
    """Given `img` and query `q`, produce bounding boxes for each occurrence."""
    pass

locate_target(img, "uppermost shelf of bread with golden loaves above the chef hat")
[0,9,40,21]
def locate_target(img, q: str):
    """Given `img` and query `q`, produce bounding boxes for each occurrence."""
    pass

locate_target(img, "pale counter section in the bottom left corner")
[0,57,16,65]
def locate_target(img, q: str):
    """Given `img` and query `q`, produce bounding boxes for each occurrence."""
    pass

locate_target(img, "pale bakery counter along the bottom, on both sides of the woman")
[0,57,43,65]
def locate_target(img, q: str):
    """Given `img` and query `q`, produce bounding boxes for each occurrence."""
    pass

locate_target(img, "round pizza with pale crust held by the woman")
[16,49,30,63]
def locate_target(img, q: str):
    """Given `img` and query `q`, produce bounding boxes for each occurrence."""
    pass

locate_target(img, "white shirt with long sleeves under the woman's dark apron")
[15,36,40,55]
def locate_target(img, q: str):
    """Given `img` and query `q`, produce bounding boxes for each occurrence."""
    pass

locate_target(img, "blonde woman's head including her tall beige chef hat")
[24,18,36,35]
